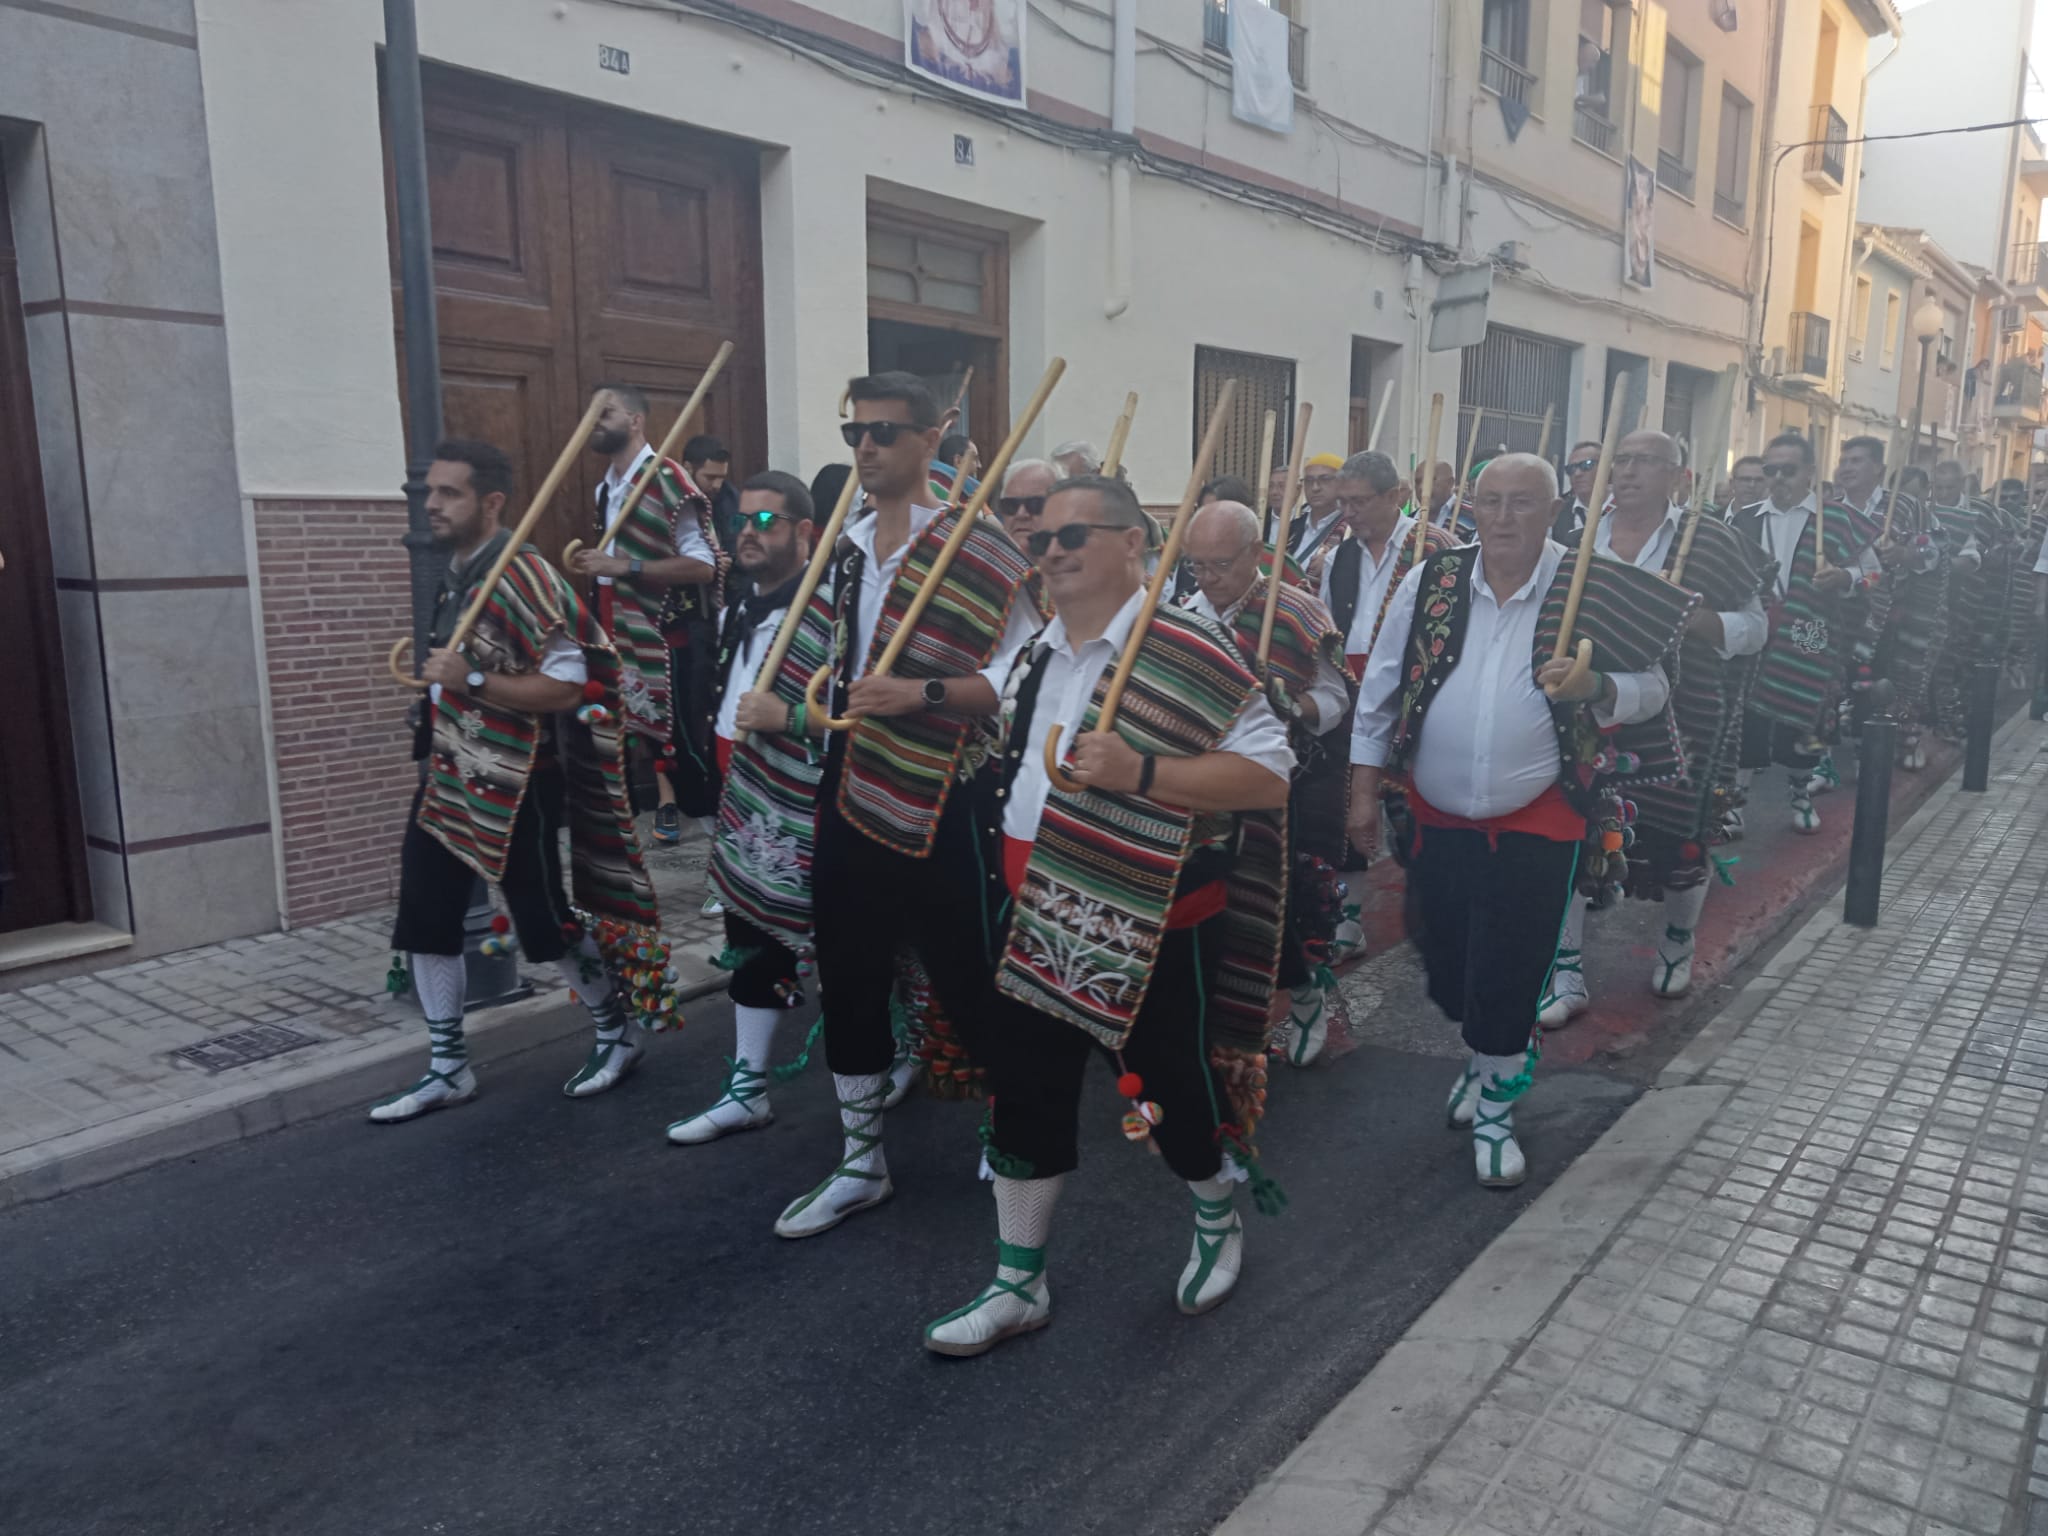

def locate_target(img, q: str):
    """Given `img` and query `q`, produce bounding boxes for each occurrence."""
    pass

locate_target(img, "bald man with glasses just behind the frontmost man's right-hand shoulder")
[1182,502,1354,1067]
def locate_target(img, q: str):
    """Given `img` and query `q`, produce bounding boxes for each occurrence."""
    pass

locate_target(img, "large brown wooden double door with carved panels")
[387,68,768,559]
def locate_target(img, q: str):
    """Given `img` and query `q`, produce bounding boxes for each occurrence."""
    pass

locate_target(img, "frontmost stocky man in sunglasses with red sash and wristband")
[926,475,1294,1356]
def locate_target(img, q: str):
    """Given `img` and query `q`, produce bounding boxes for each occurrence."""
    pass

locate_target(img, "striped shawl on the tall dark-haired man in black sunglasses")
[840,510,1030,858]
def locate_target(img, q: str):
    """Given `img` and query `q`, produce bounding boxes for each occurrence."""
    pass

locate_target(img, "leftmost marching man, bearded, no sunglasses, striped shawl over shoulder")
[371,440,674,1124]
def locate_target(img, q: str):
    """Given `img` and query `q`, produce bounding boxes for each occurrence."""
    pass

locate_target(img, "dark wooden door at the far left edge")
[0,170,92,932]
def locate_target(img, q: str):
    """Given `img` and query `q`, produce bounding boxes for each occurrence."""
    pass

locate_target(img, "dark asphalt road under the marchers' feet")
[0,974,1636,1536]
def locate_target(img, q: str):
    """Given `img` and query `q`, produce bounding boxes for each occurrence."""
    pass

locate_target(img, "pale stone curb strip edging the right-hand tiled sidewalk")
[1214,724,2030,1536]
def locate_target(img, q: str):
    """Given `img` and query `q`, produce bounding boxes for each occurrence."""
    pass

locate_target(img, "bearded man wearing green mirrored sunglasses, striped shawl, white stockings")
[668,469,831,1147]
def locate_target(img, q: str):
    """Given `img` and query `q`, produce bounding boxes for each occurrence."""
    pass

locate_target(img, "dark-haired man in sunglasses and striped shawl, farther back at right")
[1733,432,1880,834]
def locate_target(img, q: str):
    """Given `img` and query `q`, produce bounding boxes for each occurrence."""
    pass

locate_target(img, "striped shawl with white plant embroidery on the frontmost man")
[995,608,1286,1051]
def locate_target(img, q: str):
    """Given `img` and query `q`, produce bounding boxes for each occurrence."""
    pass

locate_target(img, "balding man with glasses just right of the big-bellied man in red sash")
[1538,432,1769,1030]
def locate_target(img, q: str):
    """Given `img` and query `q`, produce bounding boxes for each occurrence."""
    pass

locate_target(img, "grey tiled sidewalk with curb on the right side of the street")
[1223,721,2048,1536]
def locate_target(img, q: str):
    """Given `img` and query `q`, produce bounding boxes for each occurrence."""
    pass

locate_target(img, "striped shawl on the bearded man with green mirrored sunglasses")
[711,561,840,954]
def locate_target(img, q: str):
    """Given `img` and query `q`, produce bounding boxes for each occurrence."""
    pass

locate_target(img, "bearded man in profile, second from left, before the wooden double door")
[571,383,725,844]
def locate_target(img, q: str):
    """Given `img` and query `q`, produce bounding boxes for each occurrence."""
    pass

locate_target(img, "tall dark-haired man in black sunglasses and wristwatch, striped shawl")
[776,373,1036,1237]
